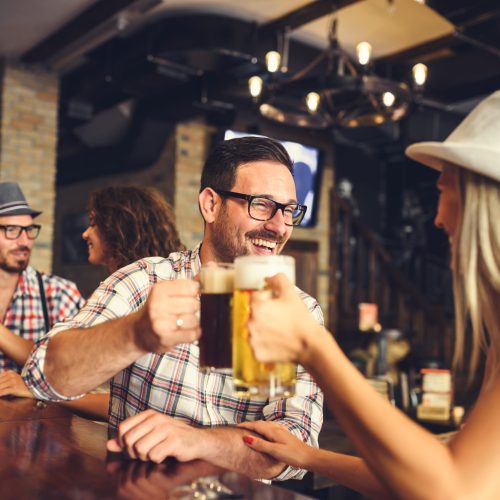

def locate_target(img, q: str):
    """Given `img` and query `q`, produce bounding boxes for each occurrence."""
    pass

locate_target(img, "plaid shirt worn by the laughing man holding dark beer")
[23,245,323,479]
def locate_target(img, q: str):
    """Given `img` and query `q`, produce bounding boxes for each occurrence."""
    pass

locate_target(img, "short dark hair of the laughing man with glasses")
[200,136,293,193]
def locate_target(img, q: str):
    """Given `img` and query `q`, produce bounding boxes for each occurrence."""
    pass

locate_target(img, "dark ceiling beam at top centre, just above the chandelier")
[259,0,361,34]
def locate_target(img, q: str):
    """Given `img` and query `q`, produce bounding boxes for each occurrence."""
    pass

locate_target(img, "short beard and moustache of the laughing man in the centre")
[212,209,284,262]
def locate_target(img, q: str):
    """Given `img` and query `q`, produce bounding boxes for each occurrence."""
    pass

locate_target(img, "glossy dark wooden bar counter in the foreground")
[0,399,307,500]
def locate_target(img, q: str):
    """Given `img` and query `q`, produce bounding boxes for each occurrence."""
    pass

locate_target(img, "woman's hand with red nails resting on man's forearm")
[238,420,315,469]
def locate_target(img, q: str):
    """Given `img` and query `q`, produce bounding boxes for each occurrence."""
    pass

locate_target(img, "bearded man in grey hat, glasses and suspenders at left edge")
[0,182,83,382]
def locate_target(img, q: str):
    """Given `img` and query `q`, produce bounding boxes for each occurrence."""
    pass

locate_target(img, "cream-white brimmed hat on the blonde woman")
[405,91,500,182]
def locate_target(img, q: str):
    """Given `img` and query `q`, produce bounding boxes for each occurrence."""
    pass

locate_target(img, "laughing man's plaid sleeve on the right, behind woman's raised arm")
[263,292,324,481]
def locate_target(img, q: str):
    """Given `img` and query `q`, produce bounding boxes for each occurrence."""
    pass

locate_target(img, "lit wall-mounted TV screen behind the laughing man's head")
[224,130,320,227]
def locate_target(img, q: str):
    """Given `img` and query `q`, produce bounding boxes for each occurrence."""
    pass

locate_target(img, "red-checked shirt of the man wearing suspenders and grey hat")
[0,266,84,372]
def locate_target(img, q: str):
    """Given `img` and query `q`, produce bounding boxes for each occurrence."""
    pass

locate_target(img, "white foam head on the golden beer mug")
[234,255,295,290]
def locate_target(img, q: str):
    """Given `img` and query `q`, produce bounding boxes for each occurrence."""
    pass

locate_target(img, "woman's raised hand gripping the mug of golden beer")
[248,273,322,364]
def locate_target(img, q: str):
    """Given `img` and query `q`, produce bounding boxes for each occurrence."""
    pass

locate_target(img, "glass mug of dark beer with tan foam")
[199,262,234,374]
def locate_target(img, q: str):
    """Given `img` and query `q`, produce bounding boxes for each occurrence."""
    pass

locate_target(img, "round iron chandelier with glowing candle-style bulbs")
[249,16,425,129]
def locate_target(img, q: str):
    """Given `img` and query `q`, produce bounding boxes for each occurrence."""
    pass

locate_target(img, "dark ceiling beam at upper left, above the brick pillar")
[21,0,136,64]
